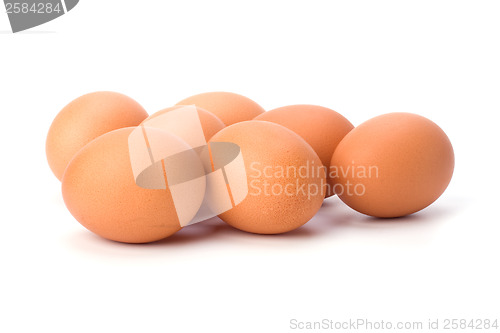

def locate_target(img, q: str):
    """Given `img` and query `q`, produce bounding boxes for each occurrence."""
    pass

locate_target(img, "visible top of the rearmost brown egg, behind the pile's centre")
[177,92,264,126]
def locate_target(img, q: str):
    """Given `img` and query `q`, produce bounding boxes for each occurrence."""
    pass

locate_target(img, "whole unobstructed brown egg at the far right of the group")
[329,113,454,217]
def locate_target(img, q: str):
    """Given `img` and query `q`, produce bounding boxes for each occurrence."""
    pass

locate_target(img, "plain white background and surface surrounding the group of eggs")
[0,0,500,332]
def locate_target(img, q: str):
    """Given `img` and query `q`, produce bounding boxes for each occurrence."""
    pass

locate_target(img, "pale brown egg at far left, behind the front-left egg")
[46,91,148,180]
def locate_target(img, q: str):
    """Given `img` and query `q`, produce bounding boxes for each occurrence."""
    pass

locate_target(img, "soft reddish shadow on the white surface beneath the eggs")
[64,193,464,257]
